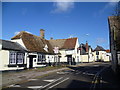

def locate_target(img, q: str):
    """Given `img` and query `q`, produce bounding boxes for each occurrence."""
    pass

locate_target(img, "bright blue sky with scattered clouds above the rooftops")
[2,2,115,49]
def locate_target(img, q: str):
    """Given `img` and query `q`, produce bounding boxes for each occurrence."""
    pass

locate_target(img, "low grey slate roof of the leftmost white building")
[0,39,26,51]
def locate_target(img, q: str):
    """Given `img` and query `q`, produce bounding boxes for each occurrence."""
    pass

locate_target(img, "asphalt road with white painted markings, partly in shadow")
[3,63,118,90]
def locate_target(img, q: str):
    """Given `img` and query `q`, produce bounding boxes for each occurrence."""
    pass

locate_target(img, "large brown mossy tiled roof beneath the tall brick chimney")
[11,31,53,54]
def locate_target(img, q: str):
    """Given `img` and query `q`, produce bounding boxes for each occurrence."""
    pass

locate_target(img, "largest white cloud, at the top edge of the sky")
[51,0,74,13]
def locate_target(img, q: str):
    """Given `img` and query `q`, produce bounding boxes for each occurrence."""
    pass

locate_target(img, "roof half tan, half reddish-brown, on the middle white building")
[49,38,77,49]
